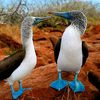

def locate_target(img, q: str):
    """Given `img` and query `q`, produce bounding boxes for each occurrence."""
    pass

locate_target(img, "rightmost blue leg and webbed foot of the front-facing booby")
[69,73,85,92]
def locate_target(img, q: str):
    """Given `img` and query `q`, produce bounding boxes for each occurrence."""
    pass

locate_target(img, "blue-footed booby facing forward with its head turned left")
[49,11,88,92]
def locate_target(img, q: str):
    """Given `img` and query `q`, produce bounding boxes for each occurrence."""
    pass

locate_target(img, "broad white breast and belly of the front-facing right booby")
[57,25,82,72]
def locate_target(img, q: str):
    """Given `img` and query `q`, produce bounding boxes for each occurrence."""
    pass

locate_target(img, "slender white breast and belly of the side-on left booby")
[7,39,37,84]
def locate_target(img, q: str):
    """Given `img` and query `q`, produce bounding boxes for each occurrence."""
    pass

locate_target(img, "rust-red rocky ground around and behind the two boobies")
[0,25,100,100]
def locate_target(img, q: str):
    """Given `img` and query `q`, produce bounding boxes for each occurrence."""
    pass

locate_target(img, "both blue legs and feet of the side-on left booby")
[10,81,31,100]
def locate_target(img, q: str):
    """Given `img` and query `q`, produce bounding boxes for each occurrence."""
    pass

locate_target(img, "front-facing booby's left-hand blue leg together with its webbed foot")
[50,71,68,91]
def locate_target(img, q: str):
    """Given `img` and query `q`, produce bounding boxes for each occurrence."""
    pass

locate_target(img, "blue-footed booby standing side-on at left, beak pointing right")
[0,17,49,99]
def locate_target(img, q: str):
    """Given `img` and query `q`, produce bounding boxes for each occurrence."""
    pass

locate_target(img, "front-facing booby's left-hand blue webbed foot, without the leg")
[50,79,68,91]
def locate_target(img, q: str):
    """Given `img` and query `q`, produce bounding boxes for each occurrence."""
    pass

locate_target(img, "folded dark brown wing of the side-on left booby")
[0,50,25,80]
